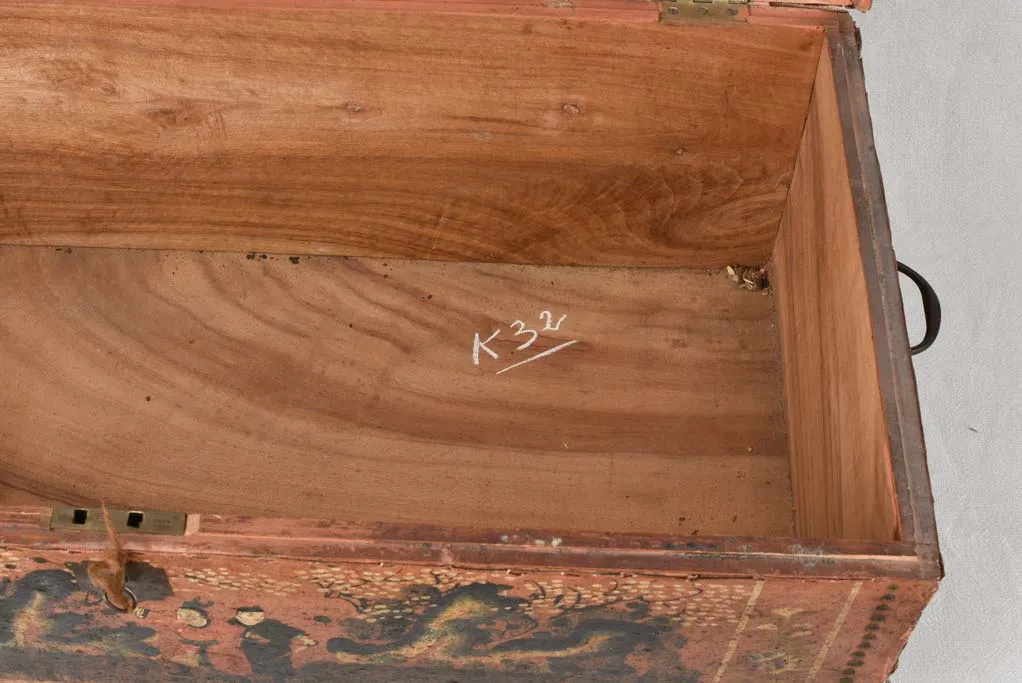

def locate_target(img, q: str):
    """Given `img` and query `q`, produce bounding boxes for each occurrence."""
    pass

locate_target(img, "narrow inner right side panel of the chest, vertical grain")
[774,45,901,541]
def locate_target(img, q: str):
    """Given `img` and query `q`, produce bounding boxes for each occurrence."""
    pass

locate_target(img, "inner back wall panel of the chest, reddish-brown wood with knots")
[0,0,822,267]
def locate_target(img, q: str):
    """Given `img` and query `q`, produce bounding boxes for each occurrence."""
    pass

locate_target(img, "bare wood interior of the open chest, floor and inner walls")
[0,2,901,541]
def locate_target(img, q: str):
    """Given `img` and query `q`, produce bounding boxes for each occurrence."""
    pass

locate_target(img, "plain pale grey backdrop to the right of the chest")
[855,0,1022,683]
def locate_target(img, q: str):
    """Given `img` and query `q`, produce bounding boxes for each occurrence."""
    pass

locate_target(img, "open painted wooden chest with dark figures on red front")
[0,0,941,683]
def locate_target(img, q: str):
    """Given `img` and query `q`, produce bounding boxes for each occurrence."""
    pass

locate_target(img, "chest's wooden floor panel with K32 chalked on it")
[0,247,792,536]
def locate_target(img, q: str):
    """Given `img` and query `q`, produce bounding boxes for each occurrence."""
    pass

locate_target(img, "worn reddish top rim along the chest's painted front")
[0,507,936,579]
